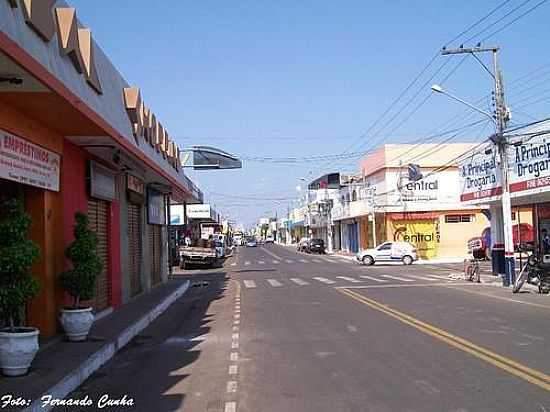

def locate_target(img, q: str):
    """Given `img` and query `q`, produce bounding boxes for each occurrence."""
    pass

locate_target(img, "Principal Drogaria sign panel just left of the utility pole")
[458,145,502,202]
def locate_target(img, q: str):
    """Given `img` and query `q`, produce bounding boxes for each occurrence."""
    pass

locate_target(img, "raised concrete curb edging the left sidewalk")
[24,280,191,412]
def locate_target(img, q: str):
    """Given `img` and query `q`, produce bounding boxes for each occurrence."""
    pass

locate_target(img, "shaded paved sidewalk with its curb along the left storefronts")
[0,279,190,411]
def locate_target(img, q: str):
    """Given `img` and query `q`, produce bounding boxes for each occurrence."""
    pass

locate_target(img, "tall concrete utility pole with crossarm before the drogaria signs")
[441,44,516,286]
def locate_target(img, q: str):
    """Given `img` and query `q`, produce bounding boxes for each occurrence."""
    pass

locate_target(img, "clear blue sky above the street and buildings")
[70,0,550,224]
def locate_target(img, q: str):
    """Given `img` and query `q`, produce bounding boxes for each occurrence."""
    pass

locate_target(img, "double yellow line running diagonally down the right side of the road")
[338,289,550,391]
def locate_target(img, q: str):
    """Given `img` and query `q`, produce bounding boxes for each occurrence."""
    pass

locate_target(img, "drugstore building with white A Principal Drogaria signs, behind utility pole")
[460,122,550,274]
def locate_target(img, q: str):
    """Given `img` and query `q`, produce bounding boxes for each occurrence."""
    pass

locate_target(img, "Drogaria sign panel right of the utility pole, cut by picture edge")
[507,134,550,192]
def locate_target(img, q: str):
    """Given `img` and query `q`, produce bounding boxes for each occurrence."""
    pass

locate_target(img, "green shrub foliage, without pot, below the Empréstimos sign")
[0,199,40,332]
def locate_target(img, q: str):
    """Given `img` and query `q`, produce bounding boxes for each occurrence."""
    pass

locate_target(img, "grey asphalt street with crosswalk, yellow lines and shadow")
[60,245,550,412]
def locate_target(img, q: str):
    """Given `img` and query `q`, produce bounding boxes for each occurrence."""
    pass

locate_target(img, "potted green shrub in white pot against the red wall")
[60,212,103,342]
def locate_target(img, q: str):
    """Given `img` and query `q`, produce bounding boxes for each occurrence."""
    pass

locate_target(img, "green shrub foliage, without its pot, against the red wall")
[61,212,103,309]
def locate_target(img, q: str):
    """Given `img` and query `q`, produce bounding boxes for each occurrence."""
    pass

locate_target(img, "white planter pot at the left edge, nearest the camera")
[0,328,39,376]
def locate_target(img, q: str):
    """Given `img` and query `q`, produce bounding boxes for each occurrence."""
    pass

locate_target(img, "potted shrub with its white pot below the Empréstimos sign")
[0,199,39,376]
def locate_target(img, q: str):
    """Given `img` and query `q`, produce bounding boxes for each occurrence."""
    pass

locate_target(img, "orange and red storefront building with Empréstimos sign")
[0,0,203,337]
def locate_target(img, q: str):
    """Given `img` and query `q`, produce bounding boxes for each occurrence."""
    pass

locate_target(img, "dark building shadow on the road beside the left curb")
[59,273,229,412]
